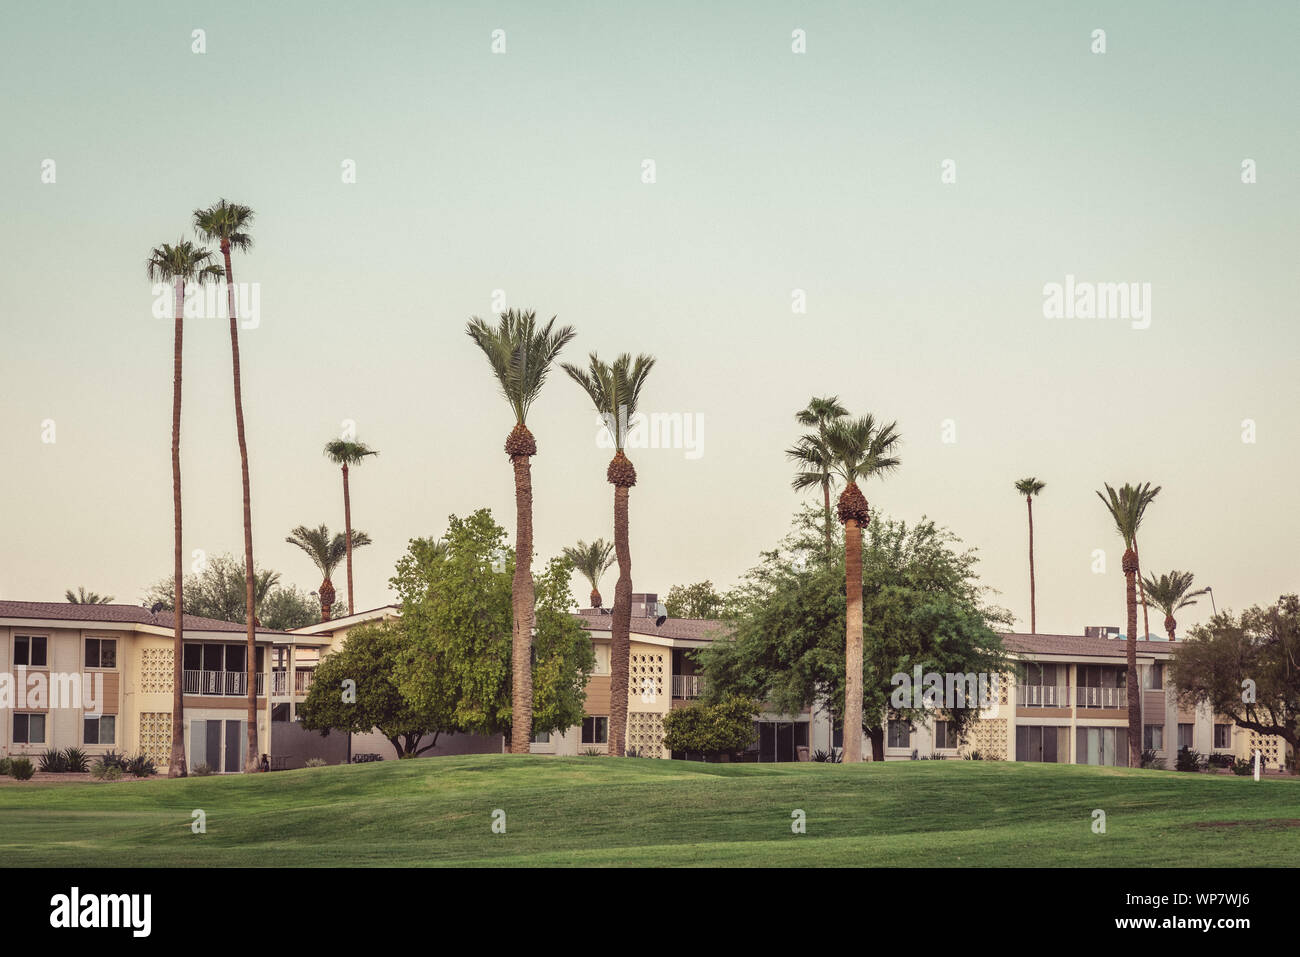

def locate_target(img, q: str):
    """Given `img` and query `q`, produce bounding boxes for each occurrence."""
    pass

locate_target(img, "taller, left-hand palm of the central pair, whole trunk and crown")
[465,309,575,754]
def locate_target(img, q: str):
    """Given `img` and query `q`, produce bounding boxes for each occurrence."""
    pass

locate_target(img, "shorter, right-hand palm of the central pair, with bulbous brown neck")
[564,352,655,757]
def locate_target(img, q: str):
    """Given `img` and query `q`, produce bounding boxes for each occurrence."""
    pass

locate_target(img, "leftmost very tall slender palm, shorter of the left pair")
[144,239,225,778]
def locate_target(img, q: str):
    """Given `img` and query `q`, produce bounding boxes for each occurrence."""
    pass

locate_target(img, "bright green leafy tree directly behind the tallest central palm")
[390,508,595,750]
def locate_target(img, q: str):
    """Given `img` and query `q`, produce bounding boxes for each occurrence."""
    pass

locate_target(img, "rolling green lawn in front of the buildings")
[0,754,1300,867]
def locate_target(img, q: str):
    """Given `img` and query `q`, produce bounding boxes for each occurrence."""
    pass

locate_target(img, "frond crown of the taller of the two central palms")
[465,309,576,455]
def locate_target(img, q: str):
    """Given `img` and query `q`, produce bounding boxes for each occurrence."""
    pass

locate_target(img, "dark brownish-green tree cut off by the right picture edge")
[1170,594,1300,772]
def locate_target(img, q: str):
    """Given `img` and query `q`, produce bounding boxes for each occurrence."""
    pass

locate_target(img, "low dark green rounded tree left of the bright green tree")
[298,622,451,758]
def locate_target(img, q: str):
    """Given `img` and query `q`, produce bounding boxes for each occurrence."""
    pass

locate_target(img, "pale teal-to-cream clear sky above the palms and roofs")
[0,1,1300,633]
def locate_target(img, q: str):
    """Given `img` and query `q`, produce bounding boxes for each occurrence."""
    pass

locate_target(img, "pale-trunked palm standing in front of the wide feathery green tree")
[826,415,902,762]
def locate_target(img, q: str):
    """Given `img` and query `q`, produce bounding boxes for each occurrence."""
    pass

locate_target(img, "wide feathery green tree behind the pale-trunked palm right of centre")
[697,510,1011,761]
